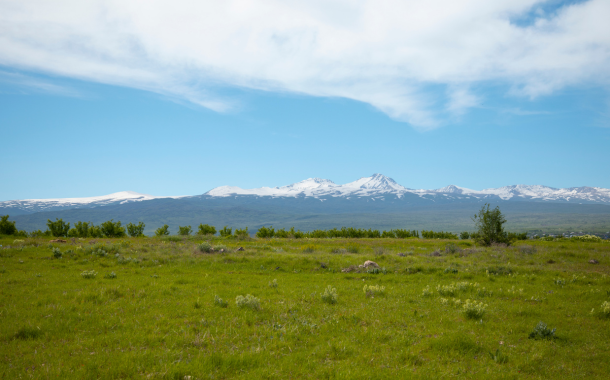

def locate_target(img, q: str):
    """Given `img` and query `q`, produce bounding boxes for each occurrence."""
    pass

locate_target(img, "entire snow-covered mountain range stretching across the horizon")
[0,174,610,215]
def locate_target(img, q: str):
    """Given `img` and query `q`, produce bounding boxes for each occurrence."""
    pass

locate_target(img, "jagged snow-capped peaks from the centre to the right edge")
[204,174,610,203]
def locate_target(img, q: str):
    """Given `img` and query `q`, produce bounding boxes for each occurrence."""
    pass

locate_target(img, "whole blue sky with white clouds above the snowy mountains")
[0,0,610,200]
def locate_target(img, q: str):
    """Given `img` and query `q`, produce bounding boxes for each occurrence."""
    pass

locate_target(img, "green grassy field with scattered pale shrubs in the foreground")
[0,237,610,379]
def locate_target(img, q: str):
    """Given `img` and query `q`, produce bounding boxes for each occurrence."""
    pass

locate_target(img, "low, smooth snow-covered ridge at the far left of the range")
[0,191,180,214]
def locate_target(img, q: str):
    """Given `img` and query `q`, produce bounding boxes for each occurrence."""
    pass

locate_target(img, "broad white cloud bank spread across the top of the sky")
[0,0,610,129]
